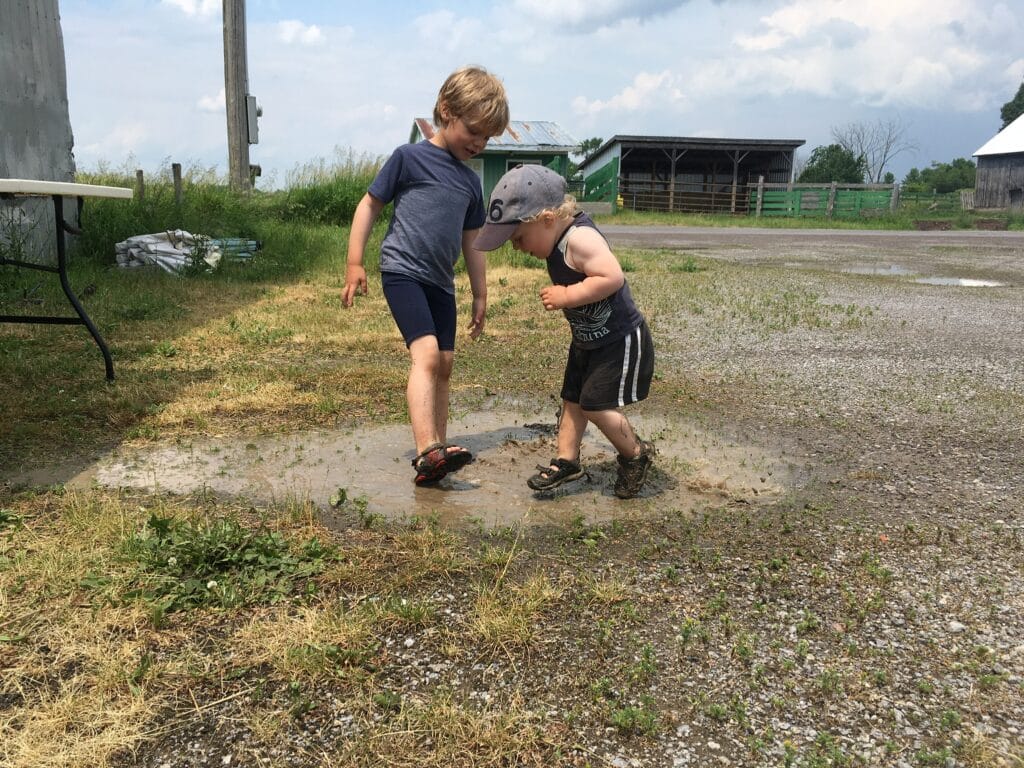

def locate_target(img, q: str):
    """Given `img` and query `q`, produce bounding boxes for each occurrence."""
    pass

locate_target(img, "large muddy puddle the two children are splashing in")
[68,411,793,525]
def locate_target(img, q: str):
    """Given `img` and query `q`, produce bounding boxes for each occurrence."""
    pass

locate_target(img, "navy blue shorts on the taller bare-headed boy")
[381,272,456,352]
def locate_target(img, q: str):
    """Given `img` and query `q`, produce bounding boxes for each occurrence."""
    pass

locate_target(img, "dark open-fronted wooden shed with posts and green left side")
[581,136,804,213]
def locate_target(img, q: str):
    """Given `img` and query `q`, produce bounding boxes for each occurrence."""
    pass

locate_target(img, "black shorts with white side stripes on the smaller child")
[562,323,654,411]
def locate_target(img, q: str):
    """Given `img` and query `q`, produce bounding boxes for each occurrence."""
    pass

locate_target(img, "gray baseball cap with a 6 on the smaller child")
[473,165,565,251]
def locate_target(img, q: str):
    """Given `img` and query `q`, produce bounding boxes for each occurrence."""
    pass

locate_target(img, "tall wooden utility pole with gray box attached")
[224,0,256,191]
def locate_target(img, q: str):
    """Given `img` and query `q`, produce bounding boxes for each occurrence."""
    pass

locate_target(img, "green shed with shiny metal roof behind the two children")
[409,118,580,199]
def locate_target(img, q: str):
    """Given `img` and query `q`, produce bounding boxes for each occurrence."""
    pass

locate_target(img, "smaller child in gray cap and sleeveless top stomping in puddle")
[474,165,654,499]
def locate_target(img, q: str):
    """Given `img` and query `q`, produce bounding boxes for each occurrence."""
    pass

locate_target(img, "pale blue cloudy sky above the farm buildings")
[59,0,1024,188]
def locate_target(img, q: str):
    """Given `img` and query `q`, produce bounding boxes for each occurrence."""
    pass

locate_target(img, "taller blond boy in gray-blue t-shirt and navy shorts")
[342,67,509,485]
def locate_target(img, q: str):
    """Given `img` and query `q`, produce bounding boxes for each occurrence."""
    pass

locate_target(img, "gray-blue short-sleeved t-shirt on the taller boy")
[370,141,483,294]
